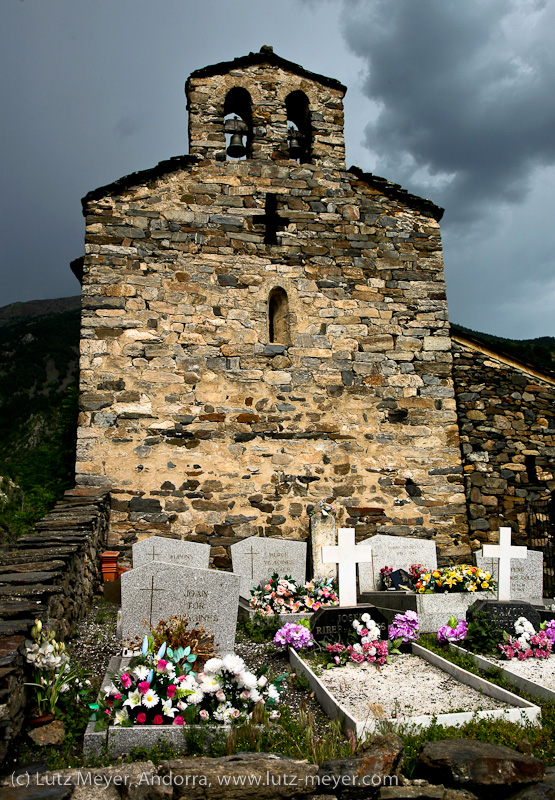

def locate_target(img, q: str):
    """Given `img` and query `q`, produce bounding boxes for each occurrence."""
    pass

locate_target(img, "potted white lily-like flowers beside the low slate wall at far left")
[25,619,84,716]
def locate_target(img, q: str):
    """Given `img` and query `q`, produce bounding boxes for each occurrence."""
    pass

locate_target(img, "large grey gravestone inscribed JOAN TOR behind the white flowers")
[121,561,240,653]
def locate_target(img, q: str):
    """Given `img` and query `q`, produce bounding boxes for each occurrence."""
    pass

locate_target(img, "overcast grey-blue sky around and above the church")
[0,0,555,338]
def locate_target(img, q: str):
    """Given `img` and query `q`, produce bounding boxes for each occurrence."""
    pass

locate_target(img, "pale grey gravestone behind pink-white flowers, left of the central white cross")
[230,536,306,599]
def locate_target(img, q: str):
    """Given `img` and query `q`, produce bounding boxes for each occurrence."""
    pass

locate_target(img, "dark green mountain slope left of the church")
[0,298,80,540]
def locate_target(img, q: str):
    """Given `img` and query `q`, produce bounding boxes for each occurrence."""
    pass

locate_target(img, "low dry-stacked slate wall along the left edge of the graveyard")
[0,488,109,764]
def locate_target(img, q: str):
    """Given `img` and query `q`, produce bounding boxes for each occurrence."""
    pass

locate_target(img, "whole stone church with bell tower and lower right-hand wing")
[74,47,555,568]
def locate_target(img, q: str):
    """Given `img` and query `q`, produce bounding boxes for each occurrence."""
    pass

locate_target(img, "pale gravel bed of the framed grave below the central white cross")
[318,653,510,722]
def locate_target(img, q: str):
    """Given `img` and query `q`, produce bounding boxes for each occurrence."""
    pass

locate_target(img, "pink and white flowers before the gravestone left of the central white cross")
[250,572,339,616]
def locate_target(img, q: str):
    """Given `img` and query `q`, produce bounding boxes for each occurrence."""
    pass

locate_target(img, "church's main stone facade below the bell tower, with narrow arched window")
[77,153,469,567]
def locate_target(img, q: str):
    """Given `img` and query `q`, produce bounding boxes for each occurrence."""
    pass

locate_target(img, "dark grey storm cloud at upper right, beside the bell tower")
[343,0,555,224]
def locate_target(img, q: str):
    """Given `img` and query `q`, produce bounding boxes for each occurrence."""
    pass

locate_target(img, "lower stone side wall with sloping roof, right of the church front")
[453,334,555,547]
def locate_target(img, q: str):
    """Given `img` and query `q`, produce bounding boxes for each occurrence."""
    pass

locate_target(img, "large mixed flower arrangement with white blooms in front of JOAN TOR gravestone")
[91,636,285,731]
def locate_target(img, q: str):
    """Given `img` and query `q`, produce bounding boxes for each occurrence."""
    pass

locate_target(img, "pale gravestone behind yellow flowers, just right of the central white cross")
[358,533,437,593]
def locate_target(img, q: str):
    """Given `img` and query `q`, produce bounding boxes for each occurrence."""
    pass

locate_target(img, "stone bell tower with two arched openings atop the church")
[185,46,347,169]
